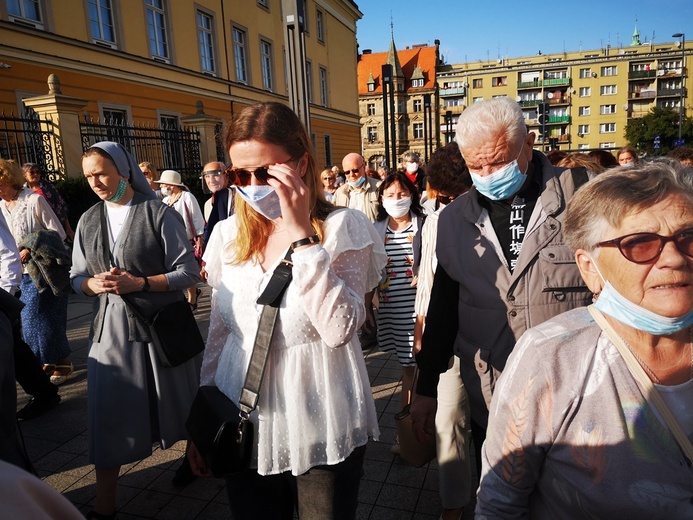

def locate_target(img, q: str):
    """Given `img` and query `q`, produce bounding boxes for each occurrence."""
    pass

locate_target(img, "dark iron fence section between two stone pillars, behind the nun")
[79,118,201,175]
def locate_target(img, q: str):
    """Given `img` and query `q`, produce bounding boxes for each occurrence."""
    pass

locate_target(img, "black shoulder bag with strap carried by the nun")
[101,201,205,367]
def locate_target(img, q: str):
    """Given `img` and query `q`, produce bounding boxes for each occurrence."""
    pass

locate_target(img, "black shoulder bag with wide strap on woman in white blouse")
[185,249,293,477]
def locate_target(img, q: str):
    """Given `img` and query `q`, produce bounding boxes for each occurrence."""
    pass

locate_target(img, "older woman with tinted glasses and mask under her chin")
[476,163,693,519]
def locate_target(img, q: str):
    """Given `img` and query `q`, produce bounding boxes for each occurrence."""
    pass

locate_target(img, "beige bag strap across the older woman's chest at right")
[587,305,693,463]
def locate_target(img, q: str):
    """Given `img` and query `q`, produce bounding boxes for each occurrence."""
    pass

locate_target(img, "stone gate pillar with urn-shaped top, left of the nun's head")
[23,74,88,177]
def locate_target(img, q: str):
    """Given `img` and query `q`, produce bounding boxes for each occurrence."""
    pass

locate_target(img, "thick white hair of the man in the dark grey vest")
[456,97,527,152]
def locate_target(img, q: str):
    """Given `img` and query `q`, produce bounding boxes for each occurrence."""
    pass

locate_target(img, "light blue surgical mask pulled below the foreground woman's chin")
[592,260,693,336]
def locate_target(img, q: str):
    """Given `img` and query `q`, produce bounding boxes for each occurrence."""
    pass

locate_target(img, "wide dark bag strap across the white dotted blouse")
[238,248,293,418]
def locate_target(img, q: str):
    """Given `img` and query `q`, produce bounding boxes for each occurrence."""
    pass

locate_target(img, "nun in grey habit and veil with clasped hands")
[70,142,199,519]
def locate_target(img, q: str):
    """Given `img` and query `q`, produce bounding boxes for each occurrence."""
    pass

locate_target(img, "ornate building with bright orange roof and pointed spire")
[358,38,440,168]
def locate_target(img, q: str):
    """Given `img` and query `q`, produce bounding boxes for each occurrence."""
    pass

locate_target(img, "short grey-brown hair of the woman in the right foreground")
[564,162,693,251]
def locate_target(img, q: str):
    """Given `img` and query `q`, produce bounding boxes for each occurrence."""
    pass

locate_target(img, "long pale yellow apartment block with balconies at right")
[437,30,693,151]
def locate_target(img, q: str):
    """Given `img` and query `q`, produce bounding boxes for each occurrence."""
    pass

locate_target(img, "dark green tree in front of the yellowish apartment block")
[626,107,693,155]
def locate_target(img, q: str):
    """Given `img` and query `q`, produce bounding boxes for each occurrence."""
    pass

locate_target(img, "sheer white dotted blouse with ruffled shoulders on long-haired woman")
[200,209,387,475]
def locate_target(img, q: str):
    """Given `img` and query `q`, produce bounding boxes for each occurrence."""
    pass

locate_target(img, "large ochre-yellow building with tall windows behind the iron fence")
[0,0,362,176]
